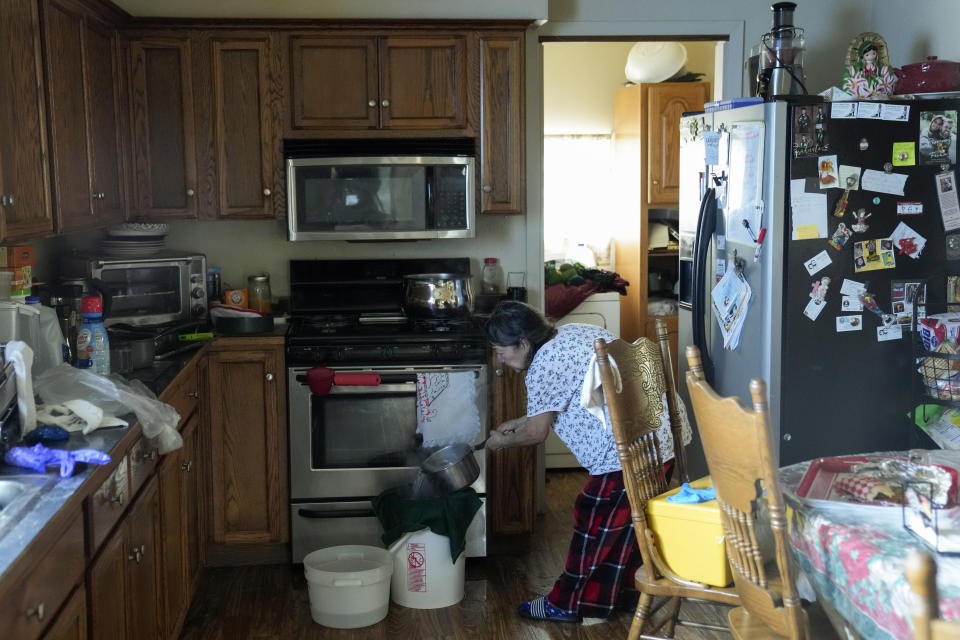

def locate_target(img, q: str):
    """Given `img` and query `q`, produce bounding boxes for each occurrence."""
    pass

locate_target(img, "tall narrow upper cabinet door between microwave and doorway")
[480,34,525,213]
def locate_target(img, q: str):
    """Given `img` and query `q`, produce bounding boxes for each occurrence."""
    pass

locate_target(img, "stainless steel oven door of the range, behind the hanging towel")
[287,365,489,501]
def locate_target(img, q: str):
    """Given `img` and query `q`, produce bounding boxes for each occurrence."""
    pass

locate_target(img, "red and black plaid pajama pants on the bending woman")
[547,471,641,618]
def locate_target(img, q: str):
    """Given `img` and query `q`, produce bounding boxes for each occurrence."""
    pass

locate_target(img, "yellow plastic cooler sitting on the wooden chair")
[647,476,733,587]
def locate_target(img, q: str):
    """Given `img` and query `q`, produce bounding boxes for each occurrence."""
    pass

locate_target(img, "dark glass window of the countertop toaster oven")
[100,265,181,317]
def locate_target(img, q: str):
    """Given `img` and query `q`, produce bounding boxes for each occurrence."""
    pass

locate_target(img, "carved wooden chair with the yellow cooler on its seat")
[594,322,740,640]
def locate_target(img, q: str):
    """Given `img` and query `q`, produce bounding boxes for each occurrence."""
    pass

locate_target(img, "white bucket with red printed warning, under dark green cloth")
[390,529,465,609]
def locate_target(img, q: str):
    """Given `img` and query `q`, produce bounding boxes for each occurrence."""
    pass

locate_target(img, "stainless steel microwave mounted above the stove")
[287,155,476,241]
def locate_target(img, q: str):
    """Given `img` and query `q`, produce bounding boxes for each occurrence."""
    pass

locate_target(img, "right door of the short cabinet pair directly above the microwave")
[380,35,471,129]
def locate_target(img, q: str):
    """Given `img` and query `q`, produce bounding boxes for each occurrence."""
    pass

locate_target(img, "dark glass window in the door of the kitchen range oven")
[310,393,422,469]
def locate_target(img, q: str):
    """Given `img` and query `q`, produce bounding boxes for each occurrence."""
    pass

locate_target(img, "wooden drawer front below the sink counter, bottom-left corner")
[0,510,86,640]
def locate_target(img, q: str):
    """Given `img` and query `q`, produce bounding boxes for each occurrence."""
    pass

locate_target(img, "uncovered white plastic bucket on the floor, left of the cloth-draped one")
[303,545,393,629]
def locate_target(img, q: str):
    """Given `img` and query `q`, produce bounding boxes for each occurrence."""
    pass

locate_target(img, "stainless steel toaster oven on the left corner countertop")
[60,251,207,325]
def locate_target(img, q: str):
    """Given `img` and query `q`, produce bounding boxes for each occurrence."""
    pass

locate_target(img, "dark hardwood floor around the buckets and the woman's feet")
[181,470,730,640]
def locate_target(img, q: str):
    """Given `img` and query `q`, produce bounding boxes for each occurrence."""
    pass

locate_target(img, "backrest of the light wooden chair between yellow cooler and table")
[687,346,809,638]
